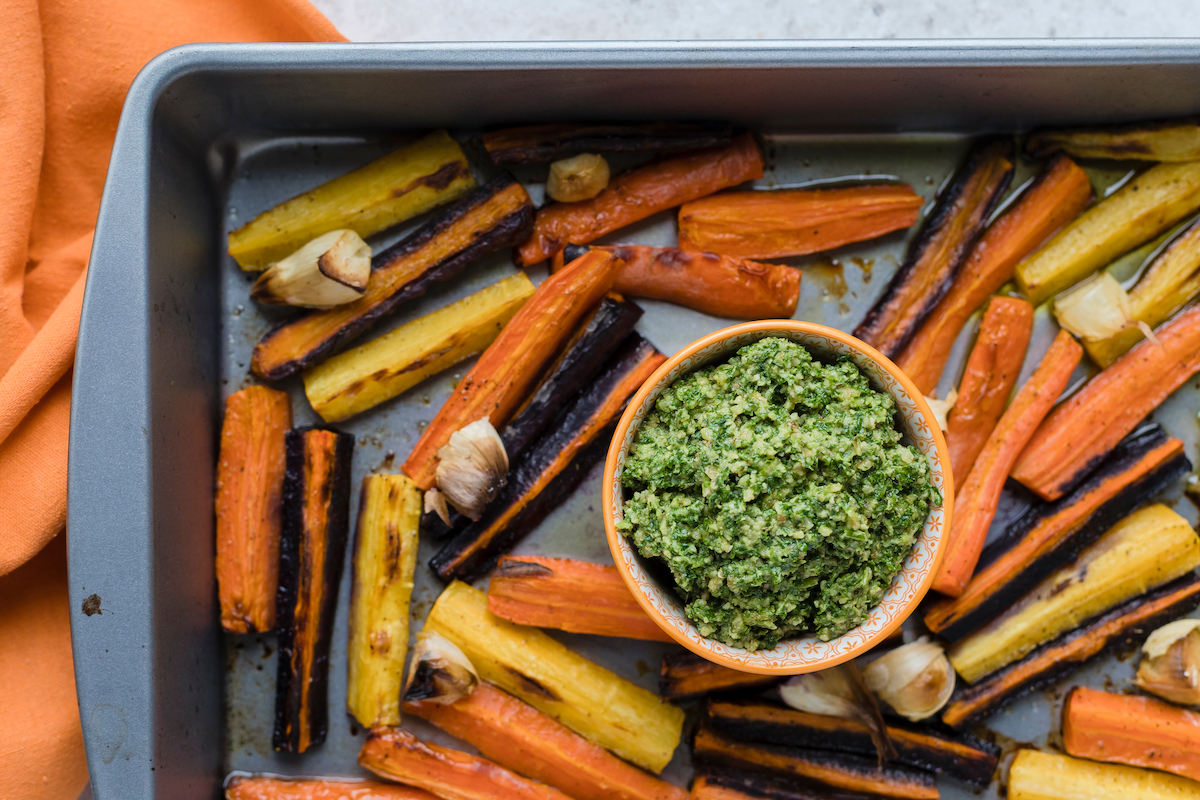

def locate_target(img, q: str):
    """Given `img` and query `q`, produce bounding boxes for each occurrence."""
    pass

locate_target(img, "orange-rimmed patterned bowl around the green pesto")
[604,320,954,675]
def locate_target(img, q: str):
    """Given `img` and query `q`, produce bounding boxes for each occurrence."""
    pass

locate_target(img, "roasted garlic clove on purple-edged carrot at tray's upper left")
[250,230,371,308]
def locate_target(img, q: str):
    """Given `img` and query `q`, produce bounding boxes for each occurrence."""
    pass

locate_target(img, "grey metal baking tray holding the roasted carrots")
[68,40,1200,800]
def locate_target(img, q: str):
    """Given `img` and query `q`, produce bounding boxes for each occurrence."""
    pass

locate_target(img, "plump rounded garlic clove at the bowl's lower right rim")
[863,636,955,722]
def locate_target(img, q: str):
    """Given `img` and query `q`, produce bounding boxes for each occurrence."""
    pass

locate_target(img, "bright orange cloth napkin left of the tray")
[0,0,346,800]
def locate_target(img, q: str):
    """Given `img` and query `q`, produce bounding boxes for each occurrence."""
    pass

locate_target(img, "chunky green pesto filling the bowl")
[617,337,941,650]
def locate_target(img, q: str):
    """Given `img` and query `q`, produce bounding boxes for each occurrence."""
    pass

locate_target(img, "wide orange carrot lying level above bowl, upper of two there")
[679,184,924,258]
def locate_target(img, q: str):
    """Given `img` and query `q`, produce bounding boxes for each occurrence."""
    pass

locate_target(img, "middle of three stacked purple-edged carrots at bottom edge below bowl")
[692,724,938,800]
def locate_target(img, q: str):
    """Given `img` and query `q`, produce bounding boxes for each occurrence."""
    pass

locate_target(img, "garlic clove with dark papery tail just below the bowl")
[779,661,896,765]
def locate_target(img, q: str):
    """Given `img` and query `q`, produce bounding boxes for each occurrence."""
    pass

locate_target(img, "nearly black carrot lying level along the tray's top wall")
[484,122,733,164]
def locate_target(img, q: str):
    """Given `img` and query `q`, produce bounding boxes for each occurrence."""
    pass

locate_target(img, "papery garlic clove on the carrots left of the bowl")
[433,416,509,524]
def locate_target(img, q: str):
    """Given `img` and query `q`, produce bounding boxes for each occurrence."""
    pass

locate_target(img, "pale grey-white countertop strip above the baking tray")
[312,0,1200,42]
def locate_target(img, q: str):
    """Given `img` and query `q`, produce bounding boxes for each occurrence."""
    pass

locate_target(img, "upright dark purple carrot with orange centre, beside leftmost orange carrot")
[272,428,354,753]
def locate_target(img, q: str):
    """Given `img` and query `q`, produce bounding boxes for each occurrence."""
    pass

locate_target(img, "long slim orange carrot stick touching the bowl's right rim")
[934,331,1084,597]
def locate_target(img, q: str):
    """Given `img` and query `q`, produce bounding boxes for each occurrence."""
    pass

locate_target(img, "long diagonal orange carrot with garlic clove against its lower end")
[402,253,620,489]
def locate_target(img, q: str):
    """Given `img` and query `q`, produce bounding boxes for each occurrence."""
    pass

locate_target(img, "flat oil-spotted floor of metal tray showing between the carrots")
[221,131,1200,800]
